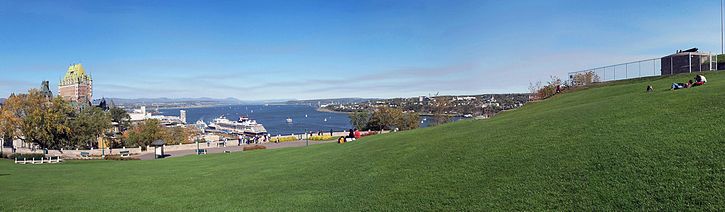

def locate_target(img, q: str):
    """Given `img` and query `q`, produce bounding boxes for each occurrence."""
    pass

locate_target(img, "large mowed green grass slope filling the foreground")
[0,73,725,211]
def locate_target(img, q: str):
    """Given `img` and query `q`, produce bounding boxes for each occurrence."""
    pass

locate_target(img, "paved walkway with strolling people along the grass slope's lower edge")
[133,140,337,160]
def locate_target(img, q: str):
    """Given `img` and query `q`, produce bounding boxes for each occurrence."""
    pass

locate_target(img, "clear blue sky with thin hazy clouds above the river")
[0,0,720,100]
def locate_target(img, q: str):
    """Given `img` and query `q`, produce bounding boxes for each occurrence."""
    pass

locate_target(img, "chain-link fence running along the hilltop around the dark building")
[568,52,718,84]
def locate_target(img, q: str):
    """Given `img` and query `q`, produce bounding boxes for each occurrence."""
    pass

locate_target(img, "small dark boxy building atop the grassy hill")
[660,48,717,75]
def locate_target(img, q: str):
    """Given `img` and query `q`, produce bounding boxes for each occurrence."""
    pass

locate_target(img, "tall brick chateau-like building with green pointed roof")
[58,63,93,103]
